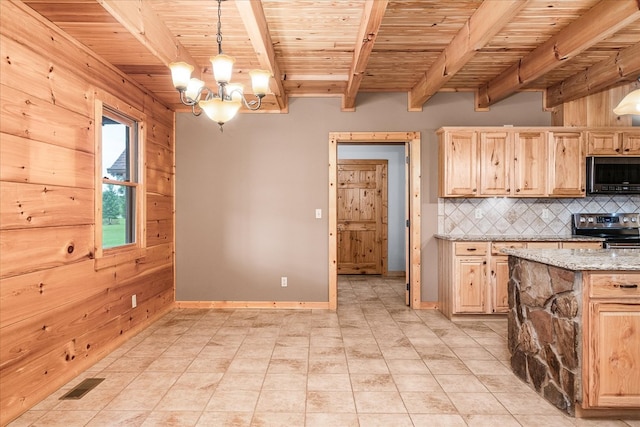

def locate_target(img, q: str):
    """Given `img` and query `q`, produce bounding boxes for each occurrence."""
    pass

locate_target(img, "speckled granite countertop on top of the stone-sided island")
[501,249,640,271]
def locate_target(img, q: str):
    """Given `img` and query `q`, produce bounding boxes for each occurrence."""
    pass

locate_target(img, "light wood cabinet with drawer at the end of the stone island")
[582,273,640,409]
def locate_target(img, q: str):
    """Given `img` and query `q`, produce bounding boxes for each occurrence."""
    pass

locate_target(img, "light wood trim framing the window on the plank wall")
[94,97,147,270]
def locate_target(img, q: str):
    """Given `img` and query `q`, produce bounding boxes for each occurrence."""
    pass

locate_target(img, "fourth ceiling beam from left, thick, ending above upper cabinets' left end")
[409,0,528,111]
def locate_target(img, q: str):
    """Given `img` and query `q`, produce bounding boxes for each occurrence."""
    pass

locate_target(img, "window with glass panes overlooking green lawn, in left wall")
[96,104,144,257]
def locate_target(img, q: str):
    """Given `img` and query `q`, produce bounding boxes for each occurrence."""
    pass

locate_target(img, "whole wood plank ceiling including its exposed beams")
[25,0,640,111]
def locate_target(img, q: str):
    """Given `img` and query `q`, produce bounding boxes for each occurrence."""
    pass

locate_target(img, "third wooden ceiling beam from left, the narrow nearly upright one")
[342,0,389,111]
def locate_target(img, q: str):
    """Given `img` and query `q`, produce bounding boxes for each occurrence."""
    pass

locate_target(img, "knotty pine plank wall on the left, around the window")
[0,0,175,425]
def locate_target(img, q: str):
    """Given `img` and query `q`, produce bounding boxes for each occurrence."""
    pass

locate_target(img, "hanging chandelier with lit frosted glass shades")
[169,0,271,131]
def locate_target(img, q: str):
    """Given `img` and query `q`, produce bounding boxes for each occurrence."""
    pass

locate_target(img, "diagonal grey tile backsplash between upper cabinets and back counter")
[438,195,640,236]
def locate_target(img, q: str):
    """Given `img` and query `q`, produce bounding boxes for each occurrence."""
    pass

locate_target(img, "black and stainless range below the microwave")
[571,213,640,249]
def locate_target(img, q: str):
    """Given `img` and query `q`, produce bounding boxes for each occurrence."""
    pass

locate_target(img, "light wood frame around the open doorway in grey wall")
[328,132,422,310]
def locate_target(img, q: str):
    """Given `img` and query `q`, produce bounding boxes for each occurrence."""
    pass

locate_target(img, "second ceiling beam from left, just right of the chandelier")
[234,0,287,111]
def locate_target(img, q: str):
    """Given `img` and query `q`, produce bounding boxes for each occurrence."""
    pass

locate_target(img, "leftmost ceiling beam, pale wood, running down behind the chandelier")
[96,0,202,78]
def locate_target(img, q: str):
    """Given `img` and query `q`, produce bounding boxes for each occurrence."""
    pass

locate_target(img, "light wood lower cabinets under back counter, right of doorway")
[438,239,602,318]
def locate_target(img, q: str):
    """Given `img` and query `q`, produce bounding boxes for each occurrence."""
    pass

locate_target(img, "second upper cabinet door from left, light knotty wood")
[480,132,513,196]
